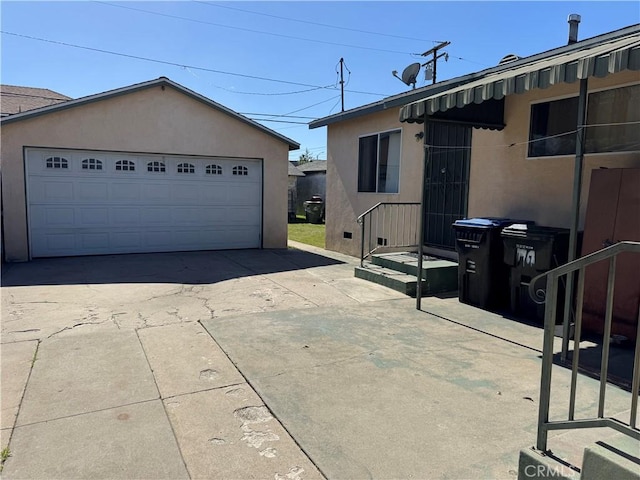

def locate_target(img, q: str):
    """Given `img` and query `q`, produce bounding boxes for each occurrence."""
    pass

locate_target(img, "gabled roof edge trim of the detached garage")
[0,77,300,150]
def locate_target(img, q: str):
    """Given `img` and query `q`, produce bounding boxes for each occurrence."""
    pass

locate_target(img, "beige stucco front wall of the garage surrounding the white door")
[0,86,289,261]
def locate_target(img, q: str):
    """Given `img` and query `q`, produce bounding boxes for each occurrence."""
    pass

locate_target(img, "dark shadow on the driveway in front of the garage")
[2,248,344,287]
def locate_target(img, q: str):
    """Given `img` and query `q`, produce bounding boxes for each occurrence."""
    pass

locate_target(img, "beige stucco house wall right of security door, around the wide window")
[468,72,640,228]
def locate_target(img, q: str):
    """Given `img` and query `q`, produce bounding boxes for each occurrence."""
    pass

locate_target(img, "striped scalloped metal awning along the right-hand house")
[400,33,640,123]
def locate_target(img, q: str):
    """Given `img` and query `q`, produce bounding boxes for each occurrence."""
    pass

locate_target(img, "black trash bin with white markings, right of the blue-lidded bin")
[501,224,569,323]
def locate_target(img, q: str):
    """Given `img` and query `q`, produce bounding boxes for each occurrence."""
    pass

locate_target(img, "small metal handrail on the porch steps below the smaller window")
[357,202,420,267]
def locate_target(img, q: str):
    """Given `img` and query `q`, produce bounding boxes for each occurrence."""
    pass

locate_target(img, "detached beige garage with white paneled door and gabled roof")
[1,78,299,261]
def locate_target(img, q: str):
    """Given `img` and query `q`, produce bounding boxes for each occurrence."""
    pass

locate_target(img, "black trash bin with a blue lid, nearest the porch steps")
[453,217,528,310]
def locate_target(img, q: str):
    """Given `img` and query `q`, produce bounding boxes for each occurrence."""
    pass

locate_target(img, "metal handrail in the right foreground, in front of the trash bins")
[529,242,640,451]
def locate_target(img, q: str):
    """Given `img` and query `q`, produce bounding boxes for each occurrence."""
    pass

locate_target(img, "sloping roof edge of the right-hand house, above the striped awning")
[309,24,640,128]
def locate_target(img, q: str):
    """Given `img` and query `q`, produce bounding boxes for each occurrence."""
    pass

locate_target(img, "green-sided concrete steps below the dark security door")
[355,254,458,298]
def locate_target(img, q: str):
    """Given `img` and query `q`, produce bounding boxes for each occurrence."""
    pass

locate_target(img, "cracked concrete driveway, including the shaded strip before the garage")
[0,244,629,480]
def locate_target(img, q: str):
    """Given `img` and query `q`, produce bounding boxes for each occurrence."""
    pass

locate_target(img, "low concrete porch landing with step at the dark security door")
[355,252,458,298]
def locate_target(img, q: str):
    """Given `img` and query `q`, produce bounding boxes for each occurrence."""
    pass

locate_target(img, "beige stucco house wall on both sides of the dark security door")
[326,72,640,256]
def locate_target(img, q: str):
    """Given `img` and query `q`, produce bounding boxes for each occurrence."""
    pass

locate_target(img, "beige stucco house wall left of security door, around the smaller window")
[325,108,423,256]
